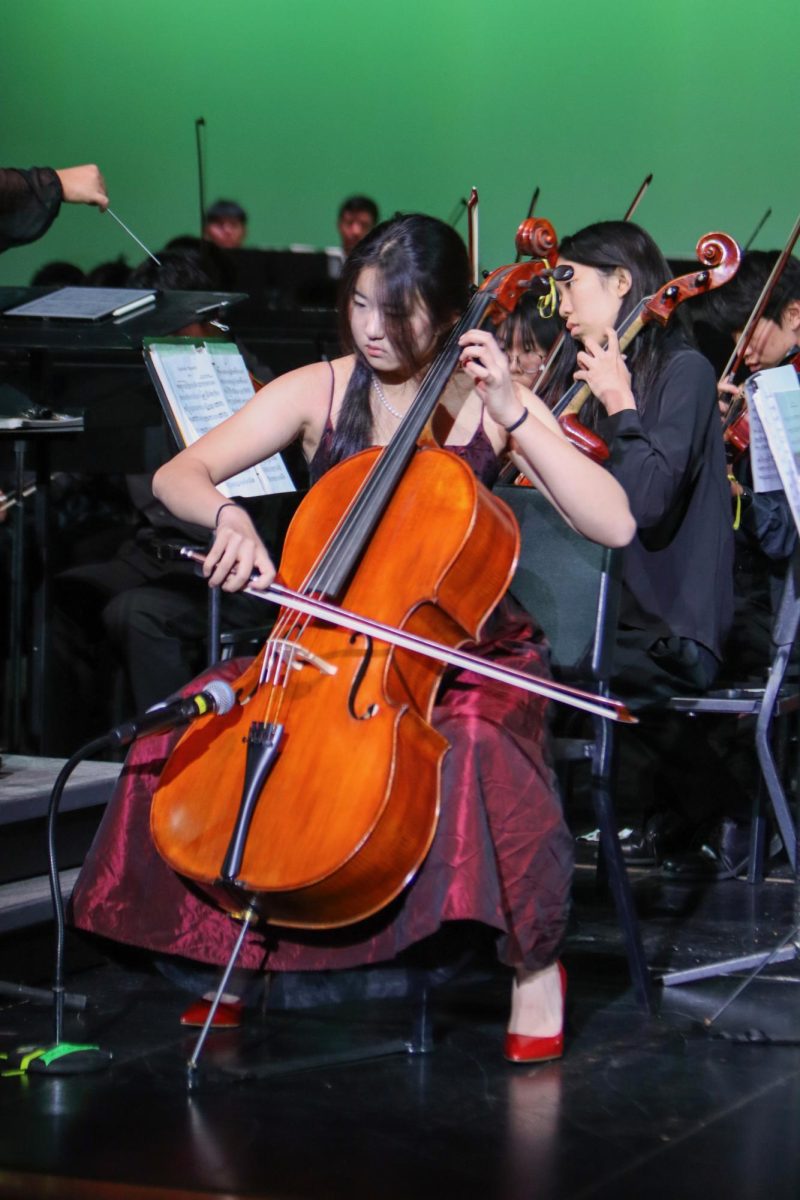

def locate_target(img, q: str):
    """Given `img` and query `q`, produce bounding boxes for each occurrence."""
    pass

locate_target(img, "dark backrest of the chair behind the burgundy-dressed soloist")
[495,487,621,682]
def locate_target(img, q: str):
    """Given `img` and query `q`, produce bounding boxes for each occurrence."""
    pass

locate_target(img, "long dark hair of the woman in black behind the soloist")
[546,221,693,425]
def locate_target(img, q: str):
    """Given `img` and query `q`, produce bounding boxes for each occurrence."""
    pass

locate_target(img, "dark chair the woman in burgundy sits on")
[495,487,654,1012]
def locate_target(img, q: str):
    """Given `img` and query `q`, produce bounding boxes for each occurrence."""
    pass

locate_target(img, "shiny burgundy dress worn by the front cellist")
[71,424,572,971]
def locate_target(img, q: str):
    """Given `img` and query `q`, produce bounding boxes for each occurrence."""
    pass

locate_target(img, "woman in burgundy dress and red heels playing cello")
[74,215,633,1062]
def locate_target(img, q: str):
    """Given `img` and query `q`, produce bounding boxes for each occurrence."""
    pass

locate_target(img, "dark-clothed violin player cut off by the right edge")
[663,251,800,881]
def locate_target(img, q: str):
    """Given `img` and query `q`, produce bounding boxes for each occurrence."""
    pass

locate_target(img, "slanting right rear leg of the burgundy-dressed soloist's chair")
[591,718,655,1013]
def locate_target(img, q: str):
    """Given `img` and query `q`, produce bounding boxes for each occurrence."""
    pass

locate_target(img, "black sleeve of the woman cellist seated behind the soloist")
[599,352,716,529]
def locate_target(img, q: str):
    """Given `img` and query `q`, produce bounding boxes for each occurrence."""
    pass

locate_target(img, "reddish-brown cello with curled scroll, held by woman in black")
[553,233,741,427]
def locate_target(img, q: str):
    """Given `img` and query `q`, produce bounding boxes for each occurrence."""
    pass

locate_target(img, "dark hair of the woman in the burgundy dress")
[331,212,469,464]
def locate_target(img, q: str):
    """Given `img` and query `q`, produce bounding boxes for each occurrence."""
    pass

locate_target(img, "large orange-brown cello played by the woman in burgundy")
[151,222,618,929]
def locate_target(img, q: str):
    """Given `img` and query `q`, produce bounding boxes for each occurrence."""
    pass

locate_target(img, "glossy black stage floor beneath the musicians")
[0,866,800,1200]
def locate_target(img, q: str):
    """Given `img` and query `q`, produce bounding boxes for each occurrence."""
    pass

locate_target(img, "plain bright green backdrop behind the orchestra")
[0,0,800,283]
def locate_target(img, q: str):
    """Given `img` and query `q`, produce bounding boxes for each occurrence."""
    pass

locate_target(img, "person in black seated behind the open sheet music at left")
[47,240,290,755]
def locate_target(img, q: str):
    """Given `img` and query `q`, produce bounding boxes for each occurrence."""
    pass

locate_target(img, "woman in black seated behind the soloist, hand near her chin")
[551,221,733,863]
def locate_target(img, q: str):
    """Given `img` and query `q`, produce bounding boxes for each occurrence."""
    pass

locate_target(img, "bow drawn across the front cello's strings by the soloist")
[175,544,637,725]
